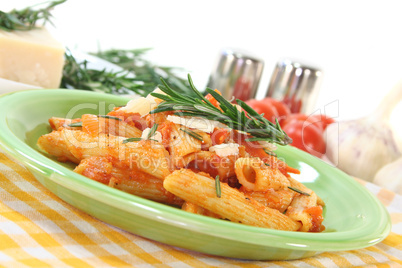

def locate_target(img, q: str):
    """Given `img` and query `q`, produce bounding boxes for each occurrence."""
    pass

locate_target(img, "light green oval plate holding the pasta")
[0,89,391,260]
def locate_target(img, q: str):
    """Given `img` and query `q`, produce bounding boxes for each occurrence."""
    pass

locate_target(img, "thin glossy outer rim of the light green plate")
[0,89,391,252]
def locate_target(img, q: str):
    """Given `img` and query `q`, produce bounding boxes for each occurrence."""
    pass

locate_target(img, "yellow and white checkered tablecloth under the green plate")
[0,151,402,267]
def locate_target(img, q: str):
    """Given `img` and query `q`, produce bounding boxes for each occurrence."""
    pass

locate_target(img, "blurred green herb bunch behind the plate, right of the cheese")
[60,48,192,97]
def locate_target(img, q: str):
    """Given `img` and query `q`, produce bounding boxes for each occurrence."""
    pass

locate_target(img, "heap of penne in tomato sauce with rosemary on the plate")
[38,77,325,232]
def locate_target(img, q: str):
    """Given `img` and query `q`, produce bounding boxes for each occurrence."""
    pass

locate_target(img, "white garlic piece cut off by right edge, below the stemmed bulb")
[373,157,402,195]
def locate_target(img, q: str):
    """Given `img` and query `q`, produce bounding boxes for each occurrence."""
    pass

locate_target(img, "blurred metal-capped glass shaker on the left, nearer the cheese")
[207,49,264,101]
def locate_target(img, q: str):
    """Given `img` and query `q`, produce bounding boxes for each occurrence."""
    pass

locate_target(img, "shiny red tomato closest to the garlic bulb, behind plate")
[282,120,325,157]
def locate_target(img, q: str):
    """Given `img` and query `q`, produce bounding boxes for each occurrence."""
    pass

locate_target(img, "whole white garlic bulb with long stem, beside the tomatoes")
[324,80,402,182]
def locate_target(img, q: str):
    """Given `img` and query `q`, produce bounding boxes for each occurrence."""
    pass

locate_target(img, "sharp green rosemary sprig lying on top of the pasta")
[150,75,292,145]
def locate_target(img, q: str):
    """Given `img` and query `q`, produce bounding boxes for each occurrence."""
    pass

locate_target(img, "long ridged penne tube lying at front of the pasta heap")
[163,169,300,231]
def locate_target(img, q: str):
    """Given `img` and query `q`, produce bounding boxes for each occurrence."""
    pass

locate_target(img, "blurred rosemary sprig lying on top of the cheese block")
[0,0,66,31]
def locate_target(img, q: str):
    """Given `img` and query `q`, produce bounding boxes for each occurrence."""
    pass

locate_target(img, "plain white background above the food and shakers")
[0,0,402,126]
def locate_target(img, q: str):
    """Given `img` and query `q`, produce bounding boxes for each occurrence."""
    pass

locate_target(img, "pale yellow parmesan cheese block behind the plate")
[0,28,65,88]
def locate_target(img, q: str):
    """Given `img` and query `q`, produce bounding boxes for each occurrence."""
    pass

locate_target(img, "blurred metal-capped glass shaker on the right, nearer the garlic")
[266,59,323,114]
